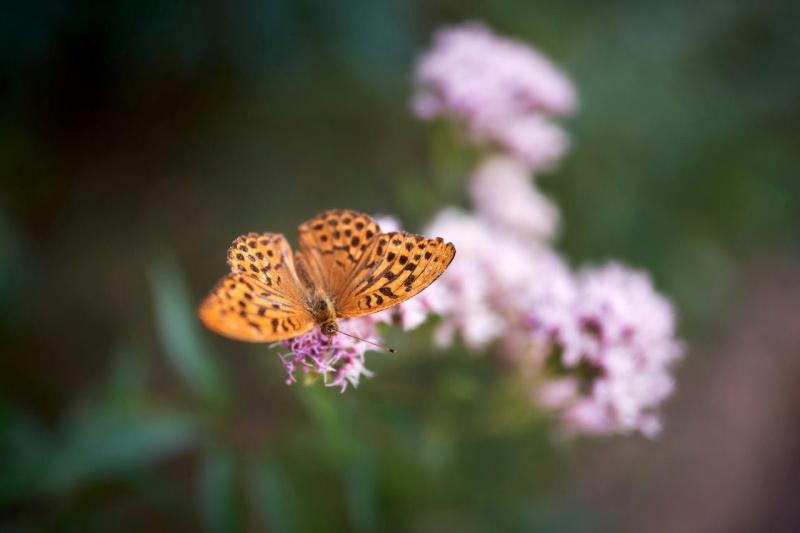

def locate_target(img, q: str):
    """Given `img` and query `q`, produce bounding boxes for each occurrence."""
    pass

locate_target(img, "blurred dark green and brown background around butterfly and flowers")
[0,0,800,532]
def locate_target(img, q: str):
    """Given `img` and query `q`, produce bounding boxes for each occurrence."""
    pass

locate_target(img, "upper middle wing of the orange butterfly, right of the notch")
[297,209,380,299]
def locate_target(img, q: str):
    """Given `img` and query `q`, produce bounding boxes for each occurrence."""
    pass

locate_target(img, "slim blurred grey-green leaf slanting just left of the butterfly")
[148,255,228,406]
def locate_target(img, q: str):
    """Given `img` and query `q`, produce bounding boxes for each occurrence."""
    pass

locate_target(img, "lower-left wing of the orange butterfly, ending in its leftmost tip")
[198,273,314,342]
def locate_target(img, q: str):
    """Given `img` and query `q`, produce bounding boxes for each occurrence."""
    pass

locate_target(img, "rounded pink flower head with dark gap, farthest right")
[529,263,683,436]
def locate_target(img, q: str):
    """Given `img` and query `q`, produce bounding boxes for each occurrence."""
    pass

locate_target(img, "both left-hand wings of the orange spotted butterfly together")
[198,233,315,342]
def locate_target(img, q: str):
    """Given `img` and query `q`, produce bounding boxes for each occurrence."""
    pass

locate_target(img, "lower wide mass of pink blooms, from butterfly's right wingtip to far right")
[428,210,682,436]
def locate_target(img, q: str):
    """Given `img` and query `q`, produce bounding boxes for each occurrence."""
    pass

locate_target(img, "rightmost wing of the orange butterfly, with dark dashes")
[335,232,456,317]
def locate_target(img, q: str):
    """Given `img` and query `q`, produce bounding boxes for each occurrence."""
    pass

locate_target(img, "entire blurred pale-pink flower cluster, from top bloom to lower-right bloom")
[414,23,682,436]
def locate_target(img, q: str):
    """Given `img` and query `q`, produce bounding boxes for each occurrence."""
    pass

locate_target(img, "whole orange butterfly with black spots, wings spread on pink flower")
[198,209,456,342]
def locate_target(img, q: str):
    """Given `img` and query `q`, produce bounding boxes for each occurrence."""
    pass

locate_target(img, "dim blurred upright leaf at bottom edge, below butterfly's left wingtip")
[200,443,242,532]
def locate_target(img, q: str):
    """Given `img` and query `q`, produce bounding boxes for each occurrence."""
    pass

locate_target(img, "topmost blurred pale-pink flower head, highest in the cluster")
[412,22,577,170]
